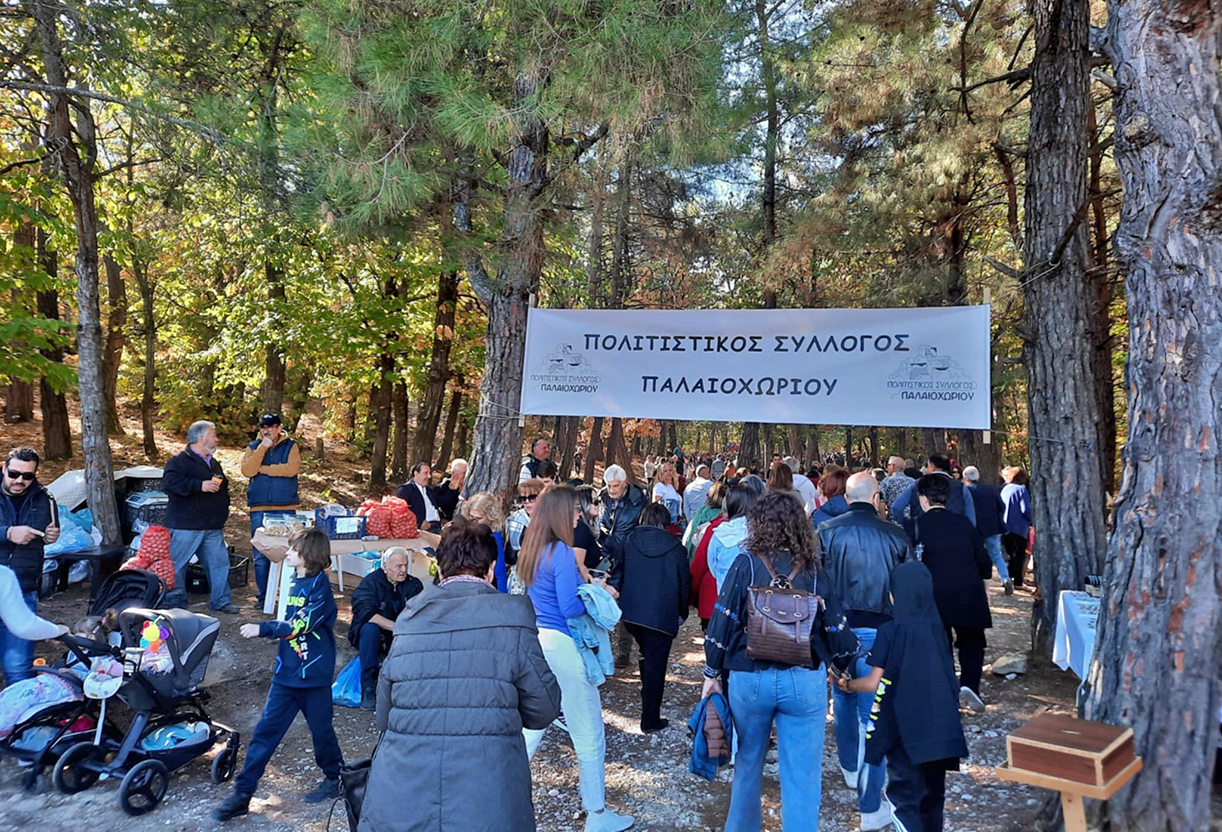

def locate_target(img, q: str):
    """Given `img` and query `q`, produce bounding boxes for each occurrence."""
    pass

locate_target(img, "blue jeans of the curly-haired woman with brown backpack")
[726,667,827,832]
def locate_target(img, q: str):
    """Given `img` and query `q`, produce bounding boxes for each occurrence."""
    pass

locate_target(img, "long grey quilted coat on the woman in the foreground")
[359,582,560,832]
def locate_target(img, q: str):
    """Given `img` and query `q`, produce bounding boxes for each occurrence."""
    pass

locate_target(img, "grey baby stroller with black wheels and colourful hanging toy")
[51,607,241,815]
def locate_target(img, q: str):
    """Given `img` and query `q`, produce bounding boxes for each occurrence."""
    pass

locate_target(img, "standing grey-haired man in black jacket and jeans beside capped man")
[161,419,237,613]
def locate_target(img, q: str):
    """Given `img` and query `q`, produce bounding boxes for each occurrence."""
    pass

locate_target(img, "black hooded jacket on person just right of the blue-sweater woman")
[607,525,692,638]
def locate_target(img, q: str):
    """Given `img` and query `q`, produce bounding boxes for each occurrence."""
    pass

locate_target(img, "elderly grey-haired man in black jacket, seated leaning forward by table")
[348,546,424,711]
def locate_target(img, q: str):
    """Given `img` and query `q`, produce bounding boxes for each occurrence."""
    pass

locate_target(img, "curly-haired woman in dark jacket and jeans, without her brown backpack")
[703,491,857,832]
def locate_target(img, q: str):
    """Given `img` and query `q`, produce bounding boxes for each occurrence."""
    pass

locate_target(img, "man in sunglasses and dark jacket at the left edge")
[0,447,60,684]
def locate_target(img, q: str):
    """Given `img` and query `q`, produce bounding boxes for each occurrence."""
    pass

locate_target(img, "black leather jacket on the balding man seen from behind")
[819,502,913,627]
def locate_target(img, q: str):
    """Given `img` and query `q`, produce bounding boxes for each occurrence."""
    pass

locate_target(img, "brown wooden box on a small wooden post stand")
[996,713,1141,832]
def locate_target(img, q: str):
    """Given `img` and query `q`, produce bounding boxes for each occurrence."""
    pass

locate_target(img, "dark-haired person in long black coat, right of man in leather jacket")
[917,474,992,711]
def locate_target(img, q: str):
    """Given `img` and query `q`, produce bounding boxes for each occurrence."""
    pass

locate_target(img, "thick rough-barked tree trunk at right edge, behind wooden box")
[1086,0,1222,832]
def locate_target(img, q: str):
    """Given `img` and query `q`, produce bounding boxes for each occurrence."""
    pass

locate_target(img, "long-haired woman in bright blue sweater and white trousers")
[518,486,633,832]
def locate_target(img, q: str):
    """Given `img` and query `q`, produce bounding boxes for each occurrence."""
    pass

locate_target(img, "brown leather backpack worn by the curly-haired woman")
[747,557,819,667]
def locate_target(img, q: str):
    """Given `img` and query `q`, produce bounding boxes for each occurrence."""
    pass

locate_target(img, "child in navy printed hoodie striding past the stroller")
[213,529,343,821]
